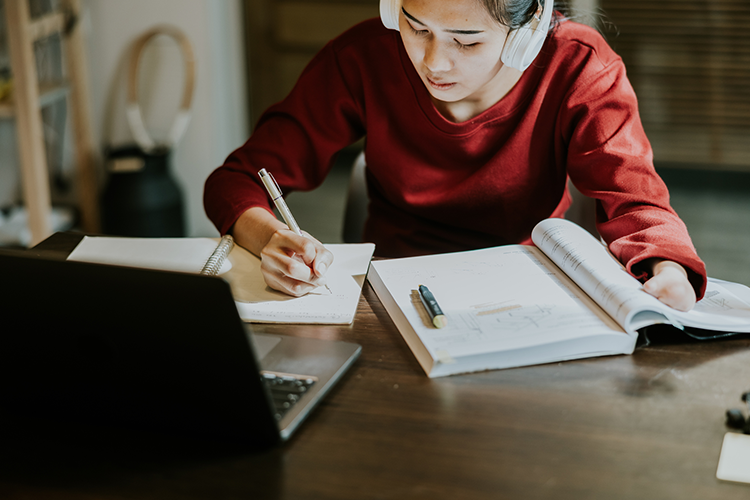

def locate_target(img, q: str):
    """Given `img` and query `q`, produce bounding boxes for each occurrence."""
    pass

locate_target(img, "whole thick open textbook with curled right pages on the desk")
[368,219,750,377]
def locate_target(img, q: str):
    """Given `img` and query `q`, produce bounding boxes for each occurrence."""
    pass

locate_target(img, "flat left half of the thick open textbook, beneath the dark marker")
[369,245,635,376]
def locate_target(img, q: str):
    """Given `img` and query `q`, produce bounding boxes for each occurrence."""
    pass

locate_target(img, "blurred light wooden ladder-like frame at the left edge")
[0,0,100,245]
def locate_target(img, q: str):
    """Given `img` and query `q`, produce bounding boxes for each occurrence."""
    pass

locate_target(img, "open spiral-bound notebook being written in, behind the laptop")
[68,236,375,324]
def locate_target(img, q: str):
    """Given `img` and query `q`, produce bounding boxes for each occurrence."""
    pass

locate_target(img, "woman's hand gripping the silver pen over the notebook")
[231,207,333,297]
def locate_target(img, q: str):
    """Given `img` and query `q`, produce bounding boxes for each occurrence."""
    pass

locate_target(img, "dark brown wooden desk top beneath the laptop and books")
[0,234,750,500]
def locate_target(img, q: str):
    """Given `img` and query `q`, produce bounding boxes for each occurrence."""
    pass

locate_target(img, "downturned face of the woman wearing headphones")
[399,0,508,103]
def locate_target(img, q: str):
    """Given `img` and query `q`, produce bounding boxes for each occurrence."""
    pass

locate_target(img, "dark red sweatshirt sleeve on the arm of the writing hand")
[203,42,364,234]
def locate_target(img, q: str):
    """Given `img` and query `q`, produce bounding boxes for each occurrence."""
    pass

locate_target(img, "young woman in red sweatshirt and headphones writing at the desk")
[204,0,706,310]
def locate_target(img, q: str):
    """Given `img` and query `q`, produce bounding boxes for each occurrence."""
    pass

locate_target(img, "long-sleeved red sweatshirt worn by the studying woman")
[204,19,706,297]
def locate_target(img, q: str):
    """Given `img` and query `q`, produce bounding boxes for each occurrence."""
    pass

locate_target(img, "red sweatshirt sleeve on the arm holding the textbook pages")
[561,58,706,299]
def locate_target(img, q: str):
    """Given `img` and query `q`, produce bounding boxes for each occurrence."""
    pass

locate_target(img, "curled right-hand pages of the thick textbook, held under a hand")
[532,219,750,333]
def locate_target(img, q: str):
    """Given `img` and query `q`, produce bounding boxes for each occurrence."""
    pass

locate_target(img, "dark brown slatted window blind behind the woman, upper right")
[599,0,750,171]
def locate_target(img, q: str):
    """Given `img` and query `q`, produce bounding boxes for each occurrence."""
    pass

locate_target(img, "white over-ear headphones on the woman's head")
[380,0,554,71]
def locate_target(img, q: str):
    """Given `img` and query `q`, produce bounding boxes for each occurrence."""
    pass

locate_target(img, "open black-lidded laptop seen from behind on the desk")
[0,250,361,446]
